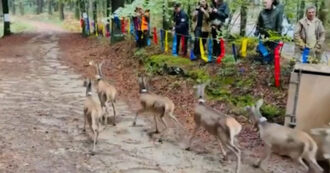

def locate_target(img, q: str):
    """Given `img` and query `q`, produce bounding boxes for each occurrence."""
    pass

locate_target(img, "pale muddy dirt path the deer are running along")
[0,20,310,173]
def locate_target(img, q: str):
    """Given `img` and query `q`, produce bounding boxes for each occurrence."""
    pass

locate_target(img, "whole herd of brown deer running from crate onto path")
[84,61,330,173]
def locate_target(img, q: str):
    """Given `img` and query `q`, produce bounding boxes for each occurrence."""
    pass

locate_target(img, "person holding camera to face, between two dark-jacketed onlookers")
[192,0,211,59]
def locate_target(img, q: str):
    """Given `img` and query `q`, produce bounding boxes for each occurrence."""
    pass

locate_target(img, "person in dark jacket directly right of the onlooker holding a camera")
[210,0,229,57]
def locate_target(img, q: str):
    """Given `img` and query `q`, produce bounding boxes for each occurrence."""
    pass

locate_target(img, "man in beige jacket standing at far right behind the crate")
[294,6,325,61]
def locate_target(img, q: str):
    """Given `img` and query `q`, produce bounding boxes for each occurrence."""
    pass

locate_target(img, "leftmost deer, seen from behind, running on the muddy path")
[83,79,103,151]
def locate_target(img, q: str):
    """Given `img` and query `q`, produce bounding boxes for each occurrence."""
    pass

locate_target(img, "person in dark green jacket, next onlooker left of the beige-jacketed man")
[254,0,283,64]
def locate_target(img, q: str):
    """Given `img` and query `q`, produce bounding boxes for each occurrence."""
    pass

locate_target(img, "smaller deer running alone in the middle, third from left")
[133,75,183,134]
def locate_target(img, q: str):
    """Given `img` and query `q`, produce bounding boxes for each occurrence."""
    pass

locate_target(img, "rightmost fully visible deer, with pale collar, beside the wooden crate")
[245,99,323,172]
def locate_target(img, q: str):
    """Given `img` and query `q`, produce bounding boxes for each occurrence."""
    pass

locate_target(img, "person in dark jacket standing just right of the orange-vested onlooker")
[173,3,189,56]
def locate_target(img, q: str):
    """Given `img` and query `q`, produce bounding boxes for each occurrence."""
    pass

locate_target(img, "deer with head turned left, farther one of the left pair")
[89,61,117,126]
